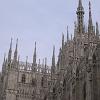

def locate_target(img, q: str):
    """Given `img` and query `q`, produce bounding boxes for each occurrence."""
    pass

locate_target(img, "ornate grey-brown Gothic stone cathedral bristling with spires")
[0,0,100,100]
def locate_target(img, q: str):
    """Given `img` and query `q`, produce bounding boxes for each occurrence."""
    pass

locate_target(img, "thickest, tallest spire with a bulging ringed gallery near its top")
[76,0,84,33]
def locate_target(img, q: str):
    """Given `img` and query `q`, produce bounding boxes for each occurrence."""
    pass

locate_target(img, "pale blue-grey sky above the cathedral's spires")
[0,0,100,70]
